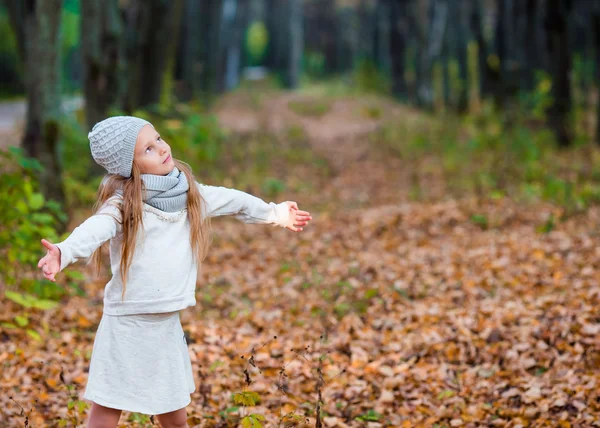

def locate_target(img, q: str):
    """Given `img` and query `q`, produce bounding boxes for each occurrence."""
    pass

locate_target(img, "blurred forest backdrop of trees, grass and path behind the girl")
[0,0,600,290]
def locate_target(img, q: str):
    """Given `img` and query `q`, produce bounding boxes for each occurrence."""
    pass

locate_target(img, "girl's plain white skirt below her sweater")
[83,311,196,415]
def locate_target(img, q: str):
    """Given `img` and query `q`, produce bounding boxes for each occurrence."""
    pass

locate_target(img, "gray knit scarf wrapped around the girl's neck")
[140,167,190,212]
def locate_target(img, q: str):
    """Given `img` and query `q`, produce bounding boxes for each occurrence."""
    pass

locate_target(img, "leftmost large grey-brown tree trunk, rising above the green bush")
[4,0,65,209]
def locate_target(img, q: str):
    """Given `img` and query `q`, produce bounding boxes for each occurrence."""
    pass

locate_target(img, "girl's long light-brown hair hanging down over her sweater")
[91,159,210,300]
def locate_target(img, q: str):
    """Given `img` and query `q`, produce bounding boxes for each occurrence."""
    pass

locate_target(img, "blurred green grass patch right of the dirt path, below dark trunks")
[371,99,600,214]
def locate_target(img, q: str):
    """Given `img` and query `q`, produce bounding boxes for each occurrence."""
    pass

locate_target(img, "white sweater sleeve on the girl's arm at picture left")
[56,198,122,271]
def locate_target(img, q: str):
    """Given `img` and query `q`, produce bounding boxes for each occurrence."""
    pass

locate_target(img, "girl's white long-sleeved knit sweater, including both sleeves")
[56,183,289,315]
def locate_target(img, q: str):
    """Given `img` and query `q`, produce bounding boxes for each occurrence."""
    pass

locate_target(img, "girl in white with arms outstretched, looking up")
[38,116,312,428]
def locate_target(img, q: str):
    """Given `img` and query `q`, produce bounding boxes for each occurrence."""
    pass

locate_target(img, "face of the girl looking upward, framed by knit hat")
[133,125,175,175]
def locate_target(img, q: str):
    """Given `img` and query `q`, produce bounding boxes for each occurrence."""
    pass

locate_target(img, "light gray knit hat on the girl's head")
[88,116,152,177]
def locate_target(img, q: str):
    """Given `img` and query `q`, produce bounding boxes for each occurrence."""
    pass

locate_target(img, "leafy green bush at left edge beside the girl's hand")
[0,147,67,290]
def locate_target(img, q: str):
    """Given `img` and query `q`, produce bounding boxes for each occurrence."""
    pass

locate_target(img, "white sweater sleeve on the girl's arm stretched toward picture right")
[196,182,290,227]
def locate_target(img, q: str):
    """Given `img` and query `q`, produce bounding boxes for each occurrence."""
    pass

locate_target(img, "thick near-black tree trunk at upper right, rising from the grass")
[546,0,571,147]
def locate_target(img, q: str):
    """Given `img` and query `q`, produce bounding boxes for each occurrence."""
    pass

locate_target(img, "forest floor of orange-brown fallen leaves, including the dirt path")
[0,92,600,427]
